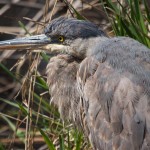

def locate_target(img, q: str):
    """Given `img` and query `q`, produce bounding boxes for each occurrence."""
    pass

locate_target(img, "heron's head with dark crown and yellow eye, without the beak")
[44,17,107,58]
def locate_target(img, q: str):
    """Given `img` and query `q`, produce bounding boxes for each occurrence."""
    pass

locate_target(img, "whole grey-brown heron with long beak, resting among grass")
[0,17,150,150]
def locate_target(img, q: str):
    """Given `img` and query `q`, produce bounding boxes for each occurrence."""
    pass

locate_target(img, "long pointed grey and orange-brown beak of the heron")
[0,34,51,50]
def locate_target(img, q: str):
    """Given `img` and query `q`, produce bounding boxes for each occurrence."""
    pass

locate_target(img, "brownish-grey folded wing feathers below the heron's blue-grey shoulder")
[78,54,150,150]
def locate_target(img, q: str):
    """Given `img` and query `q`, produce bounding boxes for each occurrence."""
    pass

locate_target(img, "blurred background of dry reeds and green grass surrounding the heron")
[0,0,150,150]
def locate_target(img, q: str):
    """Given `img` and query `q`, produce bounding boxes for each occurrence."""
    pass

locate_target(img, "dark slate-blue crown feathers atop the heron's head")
[45,17,107,39]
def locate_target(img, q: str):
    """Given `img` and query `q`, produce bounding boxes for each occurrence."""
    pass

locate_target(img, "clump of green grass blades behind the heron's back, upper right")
[103,0,150,47]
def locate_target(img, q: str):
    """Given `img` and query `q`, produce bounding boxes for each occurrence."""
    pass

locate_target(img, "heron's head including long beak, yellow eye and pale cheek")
[0,17,106,58]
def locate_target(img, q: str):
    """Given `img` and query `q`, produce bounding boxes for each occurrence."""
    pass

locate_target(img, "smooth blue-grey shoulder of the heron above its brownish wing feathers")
[84,37,150,88]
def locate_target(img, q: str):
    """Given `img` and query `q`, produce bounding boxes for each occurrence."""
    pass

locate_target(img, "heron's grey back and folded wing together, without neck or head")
[78,37,150,150]
